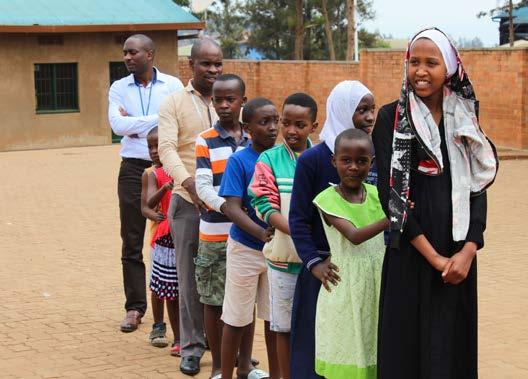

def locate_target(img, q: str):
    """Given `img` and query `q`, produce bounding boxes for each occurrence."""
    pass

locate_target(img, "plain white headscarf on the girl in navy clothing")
[319,80,372,153]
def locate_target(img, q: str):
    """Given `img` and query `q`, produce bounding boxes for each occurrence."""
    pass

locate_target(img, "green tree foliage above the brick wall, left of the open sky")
[173,0,389,60]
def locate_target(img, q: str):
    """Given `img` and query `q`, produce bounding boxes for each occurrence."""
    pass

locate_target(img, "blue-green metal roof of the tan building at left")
[0,0,203,32]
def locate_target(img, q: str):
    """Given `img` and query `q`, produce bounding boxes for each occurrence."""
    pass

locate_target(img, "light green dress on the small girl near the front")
[313,184,385,379]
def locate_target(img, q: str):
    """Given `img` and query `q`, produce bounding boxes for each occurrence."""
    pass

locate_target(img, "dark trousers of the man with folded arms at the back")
[117,158,148,314]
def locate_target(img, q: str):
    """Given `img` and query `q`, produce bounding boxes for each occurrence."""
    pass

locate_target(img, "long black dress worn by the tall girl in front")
[373,102,487,379]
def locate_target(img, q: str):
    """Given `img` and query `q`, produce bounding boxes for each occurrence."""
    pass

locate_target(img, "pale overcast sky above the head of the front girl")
[360,0,504,47]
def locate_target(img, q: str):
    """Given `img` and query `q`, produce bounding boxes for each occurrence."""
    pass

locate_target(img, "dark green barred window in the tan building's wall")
[35,63,79,113]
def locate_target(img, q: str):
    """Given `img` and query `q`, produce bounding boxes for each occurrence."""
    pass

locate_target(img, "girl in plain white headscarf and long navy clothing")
[289,81,374,379]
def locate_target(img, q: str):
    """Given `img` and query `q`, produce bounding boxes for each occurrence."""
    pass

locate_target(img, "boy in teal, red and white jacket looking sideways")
[248,93,317,378]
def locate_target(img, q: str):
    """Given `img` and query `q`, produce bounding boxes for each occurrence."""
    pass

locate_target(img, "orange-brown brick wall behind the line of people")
[179,49,528,149]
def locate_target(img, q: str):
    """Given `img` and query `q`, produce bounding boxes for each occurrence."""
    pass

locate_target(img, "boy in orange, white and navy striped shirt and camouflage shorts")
[195,74,252,377]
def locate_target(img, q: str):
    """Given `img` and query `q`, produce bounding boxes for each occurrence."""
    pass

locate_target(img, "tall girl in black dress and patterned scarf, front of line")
[373,28,498,379]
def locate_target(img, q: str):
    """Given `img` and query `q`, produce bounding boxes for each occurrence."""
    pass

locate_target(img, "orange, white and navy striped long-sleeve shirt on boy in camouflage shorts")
[196,123,250,242]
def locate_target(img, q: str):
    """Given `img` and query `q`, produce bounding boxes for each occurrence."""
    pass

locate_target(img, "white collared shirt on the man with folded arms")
[108,68,183,160]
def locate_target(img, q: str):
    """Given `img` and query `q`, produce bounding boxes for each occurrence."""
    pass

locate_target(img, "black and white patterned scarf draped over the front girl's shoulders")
[389,28,498,248]
